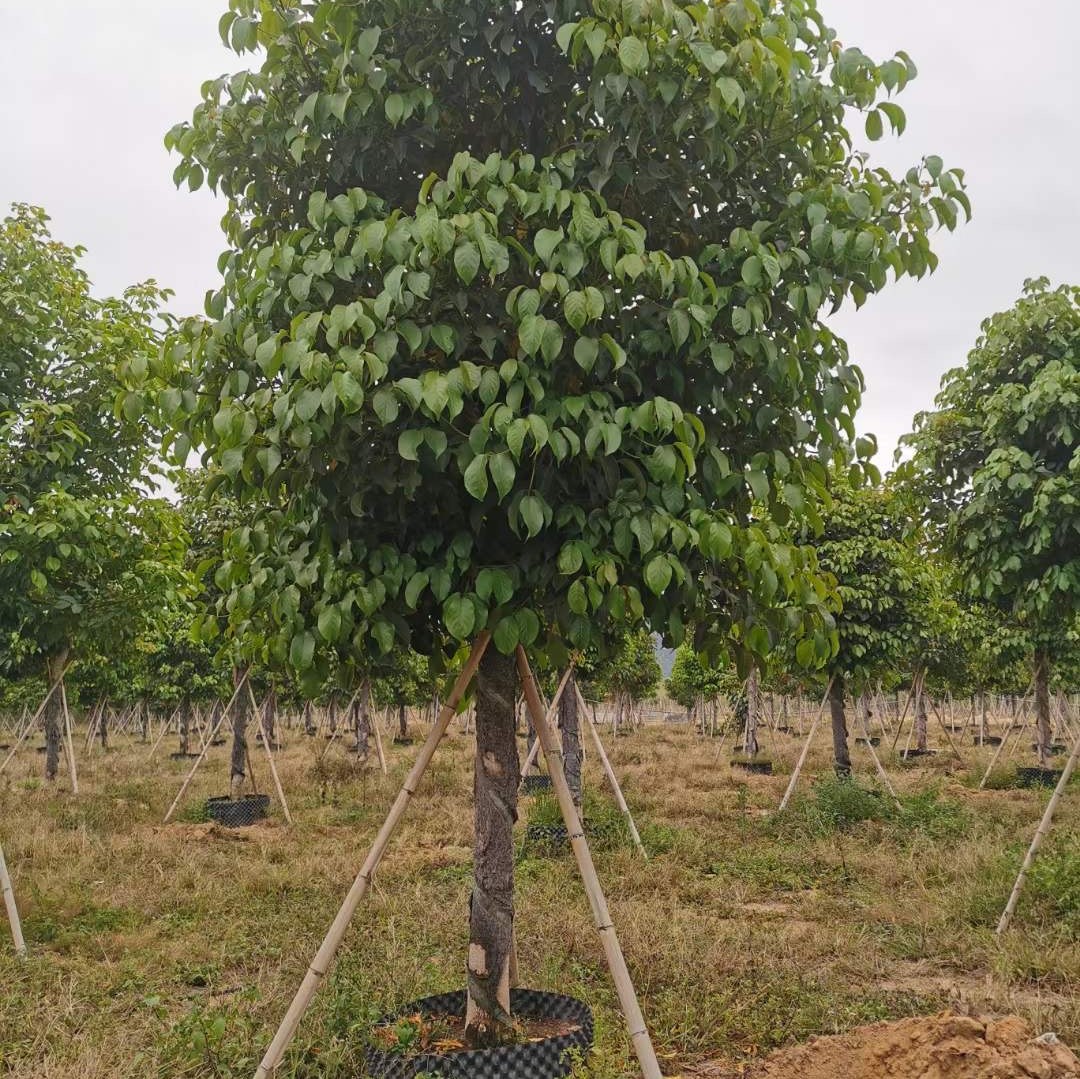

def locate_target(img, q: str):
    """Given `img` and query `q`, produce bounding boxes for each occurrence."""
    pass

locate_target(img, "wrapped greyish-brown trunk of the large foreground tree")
[465,648,521,1047]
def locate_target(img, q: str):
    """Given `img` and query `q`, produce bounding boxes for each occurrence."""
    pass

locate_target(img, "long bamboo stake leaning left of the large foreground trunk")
[255,630,491,1079]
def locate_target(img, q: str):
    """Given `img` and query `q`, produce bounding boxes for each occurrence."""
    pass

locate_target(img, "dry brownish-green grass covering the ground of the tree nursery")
[0,712,1080,1079]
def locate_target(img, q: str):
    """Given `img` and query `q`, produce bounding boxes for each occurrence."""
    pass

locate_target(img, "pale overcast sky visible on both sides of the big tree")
[0,0,1080,464]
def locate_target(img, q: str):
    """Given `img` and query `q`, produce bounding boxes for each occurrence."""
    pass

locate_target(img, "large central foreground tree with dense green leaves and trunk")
[147,0,967,1043]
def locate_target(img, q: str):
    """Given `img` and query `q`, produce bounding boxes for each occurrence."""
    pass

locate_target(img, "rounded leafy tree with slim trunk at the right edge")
[909,279,1080,766]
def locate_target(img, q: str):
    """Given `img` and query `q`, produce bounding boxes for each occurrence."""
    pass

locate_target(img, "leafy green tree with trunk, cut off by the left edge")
[0,205,180,779]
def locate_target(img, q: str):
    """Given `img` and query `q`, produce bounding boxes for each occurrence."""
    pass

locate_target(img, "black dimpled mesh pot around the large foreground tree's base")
[365,989,593,1079]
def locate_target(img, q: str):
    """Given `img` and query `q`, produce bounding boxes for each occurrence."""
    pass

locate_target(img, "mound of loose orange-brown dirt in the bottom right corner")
[687,1012,1080,1079]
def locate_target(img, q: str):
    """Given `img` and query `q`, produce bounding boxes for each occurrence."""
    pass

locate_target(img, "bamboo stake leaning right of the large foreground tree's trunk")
[517,645,662,1079]
